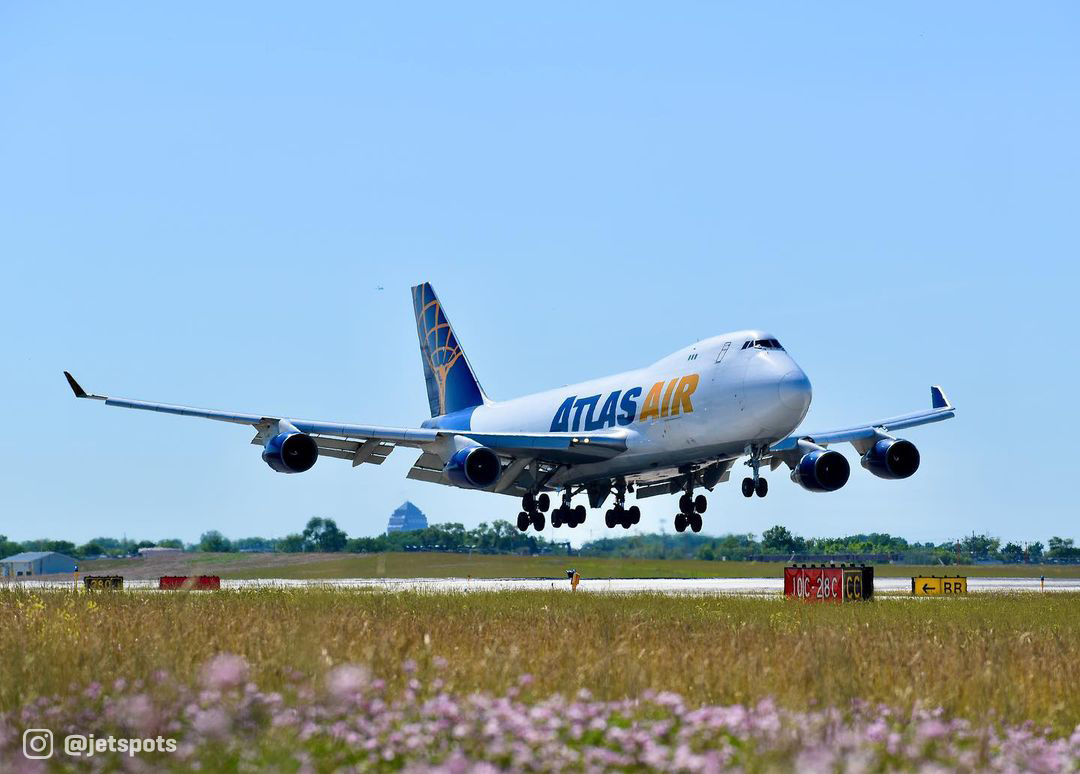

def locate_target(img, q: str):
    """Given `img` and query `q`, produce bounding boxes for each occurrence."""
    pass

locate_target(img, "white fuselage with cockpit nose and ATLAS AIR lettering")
[433,330,811,486]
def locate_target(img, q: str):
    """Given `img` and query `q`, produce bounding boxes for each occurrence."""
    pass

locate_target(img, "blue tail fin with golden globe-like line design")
[413,282,487,417]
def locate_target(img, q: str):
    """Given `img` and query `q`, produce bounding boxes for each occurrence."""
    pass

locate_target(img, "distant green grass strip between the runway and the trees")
[80,553,1080,579]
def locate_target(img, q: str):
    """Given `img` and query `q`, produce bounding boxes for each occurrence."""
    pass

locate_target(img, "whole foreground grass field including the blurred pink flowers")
[0,587,1080,771]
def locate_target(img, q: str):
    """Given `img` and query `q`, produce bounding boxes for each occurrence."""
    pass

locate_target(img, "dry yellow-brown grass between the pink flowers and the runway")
[6,589,1080,730]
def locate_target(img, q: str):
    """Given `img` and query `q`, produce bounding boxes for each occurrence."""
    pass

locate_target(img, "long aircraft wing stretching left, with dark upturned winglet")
[64,371,626,477]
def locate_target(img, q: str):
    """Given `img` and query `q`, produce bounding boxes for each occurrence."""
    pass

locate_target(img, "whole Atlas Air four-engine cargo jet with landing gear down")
[64,283,955,532]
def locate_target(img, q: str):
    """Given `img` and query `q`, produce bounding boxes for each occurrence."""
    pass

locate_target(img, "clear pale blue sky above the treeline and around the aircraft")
[0,2,1080,541]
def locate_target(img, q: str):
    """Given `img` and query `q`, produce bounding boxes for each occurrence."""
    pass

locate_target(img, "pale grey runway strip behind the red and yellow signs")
[10,578,1080,597]
